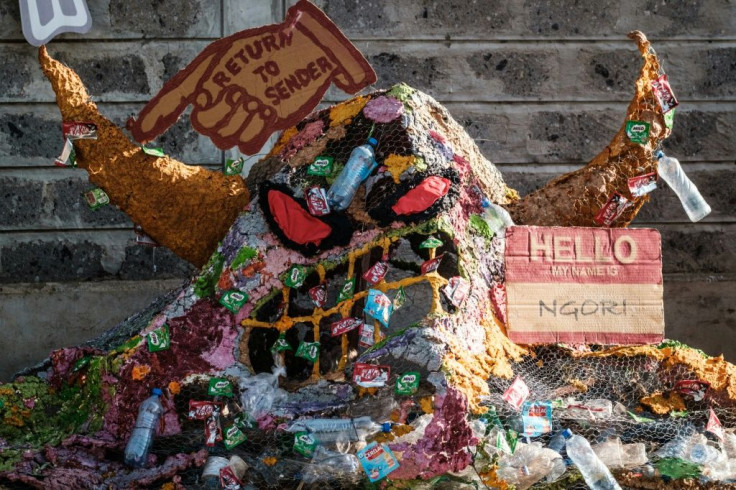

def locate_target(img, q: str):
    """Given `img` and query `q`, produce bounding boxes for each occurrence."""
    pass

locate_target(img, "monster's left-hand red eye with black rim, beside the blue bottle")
[259,182,353,256]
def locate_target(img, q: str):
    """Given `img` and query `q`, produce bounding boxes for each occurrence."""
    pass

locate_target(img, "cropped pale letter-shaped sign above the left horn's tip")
[20,0,92,46]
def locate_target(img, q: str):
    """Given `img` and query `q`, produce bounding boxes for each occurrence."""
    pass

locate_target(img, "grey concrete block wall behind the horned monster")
[0,0,736,380]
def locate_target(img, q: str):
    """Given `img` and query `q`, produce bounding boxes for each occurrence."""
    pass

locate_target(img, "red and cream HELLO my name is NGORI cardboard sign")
[506,226,664,344]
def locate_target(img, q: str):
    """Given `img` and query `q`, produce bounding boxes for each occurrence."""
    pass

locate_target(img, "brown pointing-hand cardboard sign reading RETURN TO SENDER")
[128,0,376,155]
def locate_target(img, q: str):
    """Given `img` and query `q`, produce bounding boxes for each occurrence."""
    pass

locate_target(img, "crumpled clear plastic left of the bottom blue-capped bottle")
[498,442,565,490]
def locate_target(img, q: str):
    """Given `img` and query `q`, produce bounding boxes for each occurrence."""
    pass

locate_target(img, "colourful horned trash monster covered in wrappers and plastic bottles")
[0,32,736,488]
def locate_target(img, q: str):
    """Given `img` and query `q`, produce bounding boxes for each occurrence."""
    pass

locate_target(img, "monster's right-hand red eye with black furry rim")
[366,168,460,226]
